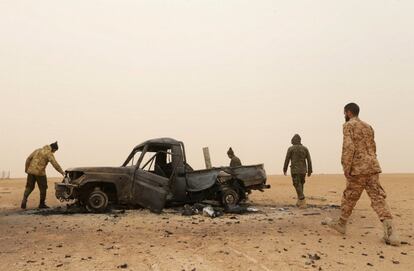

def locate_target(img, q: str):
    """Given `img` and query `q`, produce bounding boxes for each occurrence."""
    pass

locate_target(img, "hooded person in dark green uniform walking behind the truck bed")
[283,134,312,208]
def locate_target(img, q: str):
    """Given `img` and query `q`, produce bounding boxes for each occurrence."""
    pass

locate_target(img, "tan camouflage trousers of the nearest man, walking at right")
[341,174,392,221]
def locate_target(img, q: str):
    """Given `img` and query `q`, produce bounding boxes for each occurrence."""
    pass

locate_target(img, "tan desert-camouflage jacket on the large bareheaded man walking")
[341,117,381,176]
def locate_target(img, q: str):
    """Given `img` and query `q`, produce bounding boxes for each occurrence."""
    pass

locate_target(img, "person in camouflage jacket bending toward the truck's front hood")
[21,142,65,209]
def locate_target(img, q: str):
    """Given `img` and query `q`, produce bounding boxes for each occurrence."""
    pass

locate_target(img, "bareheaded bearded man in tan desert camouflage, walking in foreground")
[327,103,400,246]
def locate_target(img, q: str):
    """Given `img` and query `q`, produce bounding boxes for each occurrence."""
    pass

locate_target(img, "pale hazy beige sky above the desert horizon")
[0,0,414,177]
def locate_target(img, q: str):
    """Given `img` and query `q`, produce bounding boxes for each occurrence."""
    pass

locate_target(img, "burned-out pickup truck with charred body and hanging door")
[55,138,270,213]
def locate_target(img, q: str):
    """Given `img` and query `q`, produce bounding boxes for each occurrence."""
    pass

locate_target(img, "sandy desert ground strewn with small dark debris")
[0,174,414,270]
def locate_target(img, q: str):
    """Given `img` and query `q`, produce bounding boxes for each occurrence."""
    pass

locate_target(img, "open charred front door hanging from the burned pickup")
[133,151,169,213]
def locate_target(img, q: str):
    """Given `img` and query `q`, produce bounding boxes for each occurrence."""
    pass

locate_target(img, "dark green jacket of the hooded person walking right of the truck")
[283,144,313,174]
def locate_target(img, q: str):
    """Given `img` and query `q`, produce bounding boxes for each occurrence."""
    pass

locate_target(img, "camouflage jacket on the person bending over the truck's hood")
[25,145,65,176]
